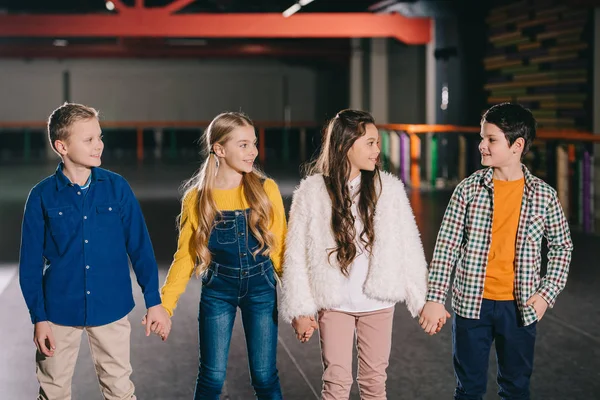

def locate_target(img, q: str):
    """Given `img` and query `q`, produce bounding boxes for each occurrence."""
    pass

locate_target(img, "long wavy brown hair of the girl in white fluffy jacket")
[309,110,381,276]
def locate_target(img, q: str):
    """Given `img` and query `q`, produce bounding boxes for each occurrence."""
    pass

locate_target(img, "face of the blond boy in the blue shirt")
[55,118,104,168]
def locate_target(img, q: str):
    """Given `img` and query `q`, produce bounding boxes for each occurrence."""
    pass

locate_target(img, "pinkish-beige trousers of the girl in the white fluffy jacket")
[319,307,394,400]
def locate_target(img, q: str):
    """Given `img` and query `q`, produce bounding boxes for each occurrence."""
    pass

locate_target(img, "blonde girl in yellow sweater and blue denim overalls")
[162,112,286,400]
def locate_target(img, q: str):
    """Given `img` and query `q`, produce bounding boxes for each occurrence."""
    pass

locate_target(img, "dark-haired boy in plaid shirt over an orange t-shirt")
[420,103,573,399]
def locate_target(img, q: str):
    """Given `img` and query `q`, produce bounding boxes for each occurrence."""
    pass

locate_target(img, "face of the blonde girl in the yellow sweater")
[214,125,258,173]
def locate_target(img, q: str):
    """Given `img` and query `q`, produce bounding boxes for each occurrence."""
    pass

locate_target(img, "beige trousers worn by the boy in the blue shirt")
[36,317,135,400]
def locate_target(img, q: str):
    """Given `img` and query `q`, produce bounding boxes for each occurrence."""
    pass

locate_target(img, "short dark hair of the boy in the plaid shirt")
[481,103,537,155]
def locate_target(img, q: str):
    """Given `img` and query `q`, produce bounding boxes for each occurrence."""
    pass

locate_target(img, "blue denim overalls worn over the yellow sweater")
[194,209,282,400]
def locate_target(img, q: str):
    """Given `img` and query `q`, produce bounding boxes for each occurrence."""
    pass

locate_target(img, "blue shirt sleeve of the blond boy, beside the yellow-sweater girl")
[120,182,161,308]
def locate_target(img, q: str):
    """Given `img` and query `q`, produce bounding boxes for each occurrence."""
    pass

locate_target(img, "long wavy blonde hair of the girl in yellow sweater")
[179,112,275,275]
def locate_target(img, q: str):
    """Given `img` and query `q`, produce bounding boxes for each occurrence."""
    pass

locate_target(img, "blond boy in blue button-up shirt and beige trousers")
[19,103,171,400]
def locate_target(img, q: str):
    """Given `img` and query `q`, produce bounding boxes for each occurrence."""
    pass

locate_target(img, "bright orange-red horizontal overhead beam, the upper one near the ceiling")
[0,12,431,45]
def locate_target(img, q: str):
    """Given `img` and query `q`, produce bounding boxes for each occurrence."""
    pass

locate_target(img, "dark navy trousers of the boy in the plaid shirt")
[452,299,537,400]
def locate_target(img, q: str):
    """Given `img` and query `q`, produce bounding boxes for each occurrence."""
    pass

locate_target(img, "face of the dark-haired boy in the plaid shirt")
[479,122,524,168]
